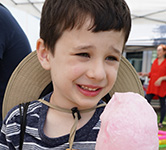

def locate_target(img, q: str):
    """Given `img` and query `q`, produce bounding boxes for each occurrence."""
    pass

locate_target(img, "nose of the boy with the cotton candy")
[87,62,106,81]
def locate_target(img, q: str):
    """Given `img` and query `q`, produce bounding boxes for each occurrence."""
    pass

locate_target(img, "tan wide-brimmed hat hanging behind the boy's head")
[2,51,144,118]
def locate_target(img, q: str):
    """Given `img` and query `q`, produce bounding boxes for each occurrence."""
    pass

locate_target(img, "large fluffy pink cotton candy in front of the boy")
[96,92,159,150]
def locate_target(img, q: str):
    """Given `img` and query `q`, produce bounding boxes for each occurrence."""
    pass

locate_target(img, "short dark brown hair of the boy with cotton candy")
[40,0,131,54]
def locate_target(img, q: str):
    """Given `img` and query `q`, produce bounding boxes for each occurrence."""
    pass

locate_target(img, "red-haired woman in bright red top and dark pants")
[139,44,166,128]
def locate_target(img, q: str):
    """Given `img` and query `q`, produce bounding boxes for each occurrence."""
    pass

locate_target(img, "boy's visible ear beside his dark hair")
[36,38,50,70]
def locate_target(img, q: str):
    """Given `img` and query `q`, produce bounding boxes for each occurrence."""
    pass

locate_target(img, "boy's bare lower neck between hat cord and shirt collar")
[44,108,95,138]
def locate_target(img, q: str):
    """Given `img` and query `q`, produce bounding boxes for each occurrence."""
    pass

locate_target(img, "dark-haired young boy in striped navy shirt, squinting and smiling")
[0,0,131,150]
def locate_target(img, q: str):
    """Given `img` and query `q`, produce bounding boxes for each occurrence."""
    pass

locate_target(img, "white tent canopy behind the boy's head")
[1,0,166,51]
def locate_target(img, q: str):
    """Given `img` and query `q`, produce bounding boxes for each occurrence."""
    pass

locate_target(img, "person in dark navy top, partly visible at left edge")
[0,3,31,128]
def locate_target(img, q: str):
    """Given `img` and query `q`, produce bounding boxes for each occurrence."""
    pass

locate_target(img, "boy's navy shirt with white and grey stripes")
[0,94,104,150]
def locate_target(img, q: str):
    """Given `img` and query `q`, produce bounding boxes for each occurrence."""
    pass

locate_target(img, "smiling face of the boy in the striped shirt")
[38,17,124,109]
